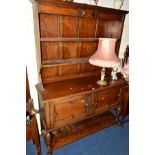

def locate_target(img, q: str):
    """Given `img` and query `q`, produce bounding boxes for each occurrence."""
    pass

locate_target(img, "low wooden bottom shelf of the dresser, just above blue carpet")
[43,112,116,149]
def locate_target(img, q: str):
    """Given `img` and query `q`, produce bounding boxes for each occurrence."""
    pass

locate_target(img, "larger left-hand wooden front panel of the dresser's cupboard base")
[54,96,89,127]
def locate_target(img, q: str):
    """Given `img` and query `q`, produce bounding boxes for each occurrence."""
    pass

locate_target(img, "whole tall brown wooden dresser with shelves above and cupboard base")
[32,0,128,155]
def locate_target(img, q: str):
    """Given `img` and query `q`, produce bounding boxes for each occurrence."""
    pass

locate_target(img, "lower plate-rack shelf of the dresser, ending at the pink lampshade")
[42,58,89,67]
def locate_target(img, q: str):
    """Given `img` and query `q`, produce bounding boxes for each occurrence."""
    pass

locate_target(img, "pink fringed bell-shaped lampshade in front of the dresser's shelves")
[89,38,121,68]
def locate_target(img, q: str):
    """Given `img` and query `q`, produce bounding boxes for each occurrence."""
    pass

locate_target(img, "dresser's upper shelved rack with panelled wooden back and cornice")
[33,0,128,85]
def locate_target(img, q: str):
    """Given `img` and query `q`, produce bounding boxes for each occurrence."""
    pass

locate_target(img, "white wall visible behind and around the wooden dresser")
[25,0,129,132]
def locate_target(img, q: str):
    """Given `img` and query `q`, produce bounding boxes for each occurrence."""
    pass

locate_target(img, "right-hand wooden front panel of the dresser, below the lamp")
[93,89,120,112]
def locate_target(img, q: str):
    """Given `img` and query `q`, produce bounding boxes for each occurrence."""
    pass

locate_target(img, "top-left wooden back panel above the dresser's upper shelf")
[40,14,58,37]
